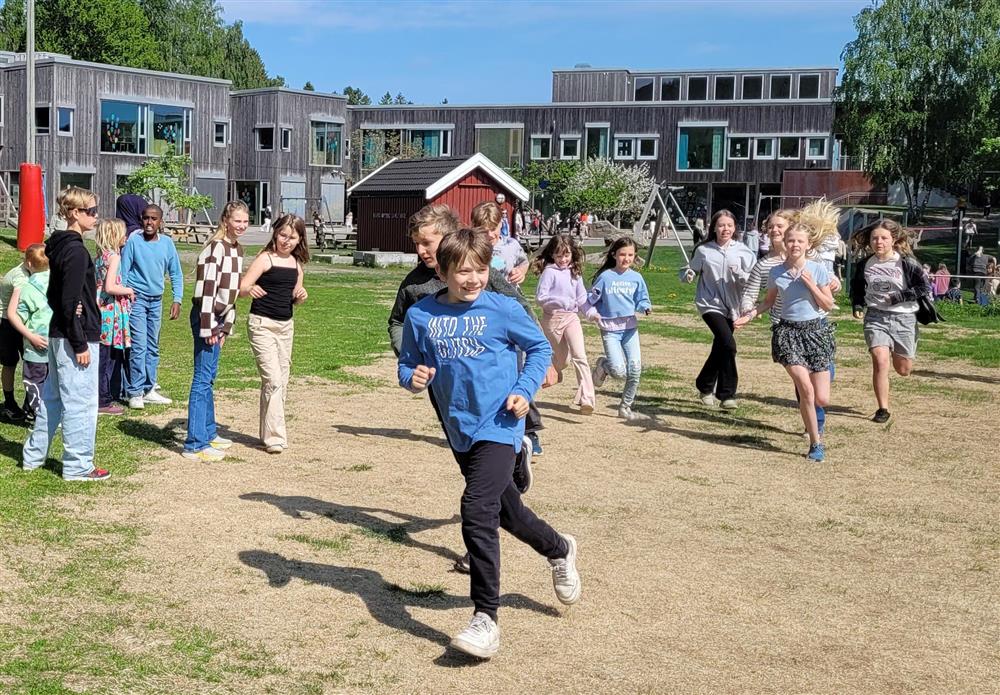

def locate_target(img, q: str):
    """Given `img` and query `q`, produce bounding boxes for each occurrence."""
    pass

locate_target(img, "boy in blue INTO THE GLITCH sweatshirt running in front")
[399,229,580,659]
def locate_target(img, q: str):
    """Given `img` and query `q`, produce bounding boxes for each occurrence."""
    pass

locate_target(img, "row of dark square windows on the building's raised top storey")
[632,74,820,101]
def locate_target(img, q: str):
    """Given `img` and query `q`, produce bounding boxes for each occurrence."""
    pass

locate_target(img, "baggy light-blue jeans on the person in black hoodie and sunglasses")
[23,338,100,478]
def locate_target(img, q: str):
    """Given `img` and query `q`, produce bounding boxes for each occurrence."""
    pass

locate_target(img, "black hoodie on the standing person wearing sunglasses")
[45,230,101,354]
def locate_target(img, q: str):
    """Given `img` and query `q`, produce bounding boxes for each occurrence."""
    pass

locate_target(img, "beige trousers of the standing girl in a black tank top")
[247,314,295,446]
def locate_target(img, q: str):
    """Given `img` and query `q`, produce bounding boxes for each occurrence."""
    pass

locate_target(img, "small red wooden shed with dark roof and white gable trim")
[347,154,528,252]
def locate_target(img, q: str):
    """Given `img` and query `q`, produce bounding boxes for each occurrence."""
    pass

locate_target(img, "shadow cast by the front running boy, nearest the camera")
[239,550,559,646]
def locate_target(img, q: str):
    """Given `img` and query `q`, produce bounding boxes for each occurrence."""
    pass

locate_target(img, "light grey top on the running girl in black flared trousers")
[681,241,757,318]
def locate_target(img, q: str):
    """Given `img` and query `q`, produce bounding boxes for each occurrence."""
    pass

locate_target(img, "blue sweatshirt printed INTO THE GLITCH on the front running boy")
[398,289,552,452]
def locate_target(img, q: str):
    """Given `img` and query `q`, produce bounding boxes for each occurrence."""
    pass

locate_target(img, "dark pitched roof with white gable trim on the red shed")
[347,154,530,200]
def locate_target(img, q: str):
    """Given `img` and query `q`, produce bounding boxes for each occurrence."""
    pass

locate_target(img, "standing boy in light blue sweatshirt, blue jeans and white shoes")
[121,205,184,408]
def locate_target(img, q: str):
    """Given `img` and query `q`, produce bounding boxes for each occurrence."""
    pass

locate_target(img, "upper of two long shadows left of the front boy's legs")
[240,492,461,562]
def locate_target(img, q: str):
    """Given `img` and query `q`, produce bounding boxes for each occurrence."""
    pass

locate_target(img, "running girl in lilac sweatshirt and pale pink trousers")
[534,234,594,415]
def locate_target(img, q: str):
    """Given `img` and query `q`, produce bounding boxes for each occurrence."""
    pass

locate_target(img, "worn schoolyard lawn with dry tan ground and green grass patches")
[0,234,1000,695]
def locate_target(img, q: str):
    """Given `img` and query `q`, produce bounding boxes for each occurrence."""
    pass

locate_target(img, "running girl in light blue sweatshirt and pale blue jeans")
[587,237,653,420]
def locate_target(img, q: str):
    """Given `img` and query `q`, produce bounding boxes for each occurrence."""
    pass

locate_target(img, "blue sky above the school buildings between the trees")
[220,0,871,104]
